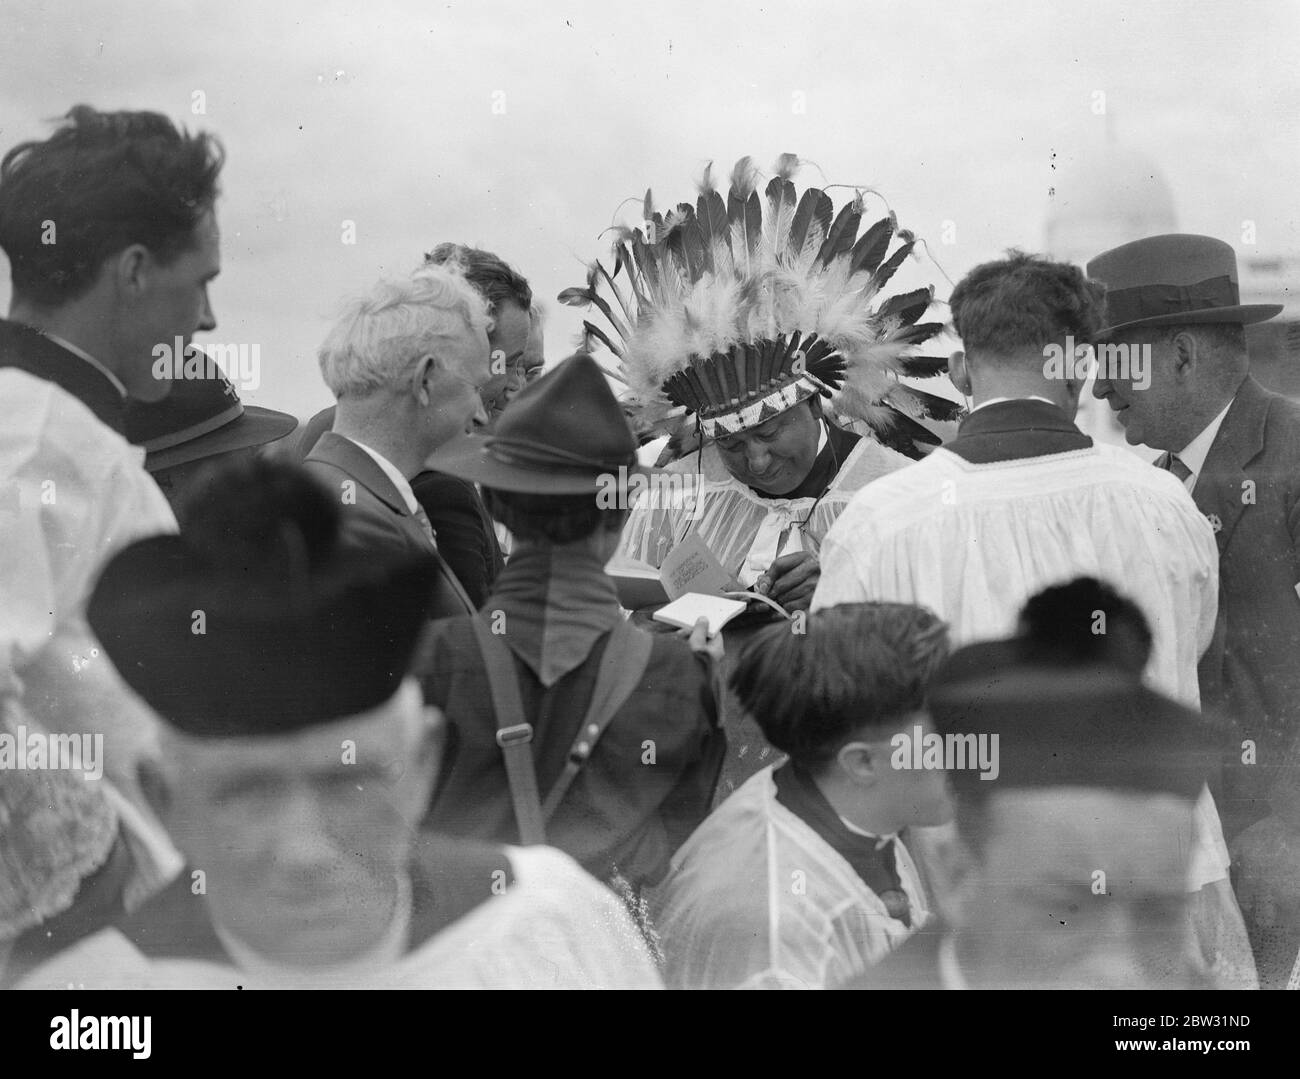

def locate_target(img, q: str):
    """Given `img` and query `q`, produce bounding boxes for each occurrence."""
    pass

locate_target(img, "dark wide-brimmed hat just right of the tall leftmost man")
[125,363,298,472]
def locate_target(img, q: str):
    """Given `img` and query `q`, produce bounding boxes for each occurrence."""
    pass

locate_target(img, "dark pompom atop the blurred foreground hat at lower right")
[1019,577,1152,676]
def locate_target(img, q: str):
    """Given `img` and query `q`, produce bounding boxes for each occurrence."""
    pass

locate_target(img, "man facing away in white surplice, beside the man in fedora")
[813,252,1240,987]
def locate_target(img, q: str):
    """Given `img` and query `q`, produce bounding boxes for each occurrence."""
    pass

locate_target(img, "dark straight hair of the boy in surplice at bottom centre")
[731,603,948,771]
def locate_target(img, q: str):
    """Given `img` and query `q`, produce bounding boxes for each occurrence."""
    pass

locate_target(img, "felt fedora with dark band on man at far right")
[1088,233,1282,339]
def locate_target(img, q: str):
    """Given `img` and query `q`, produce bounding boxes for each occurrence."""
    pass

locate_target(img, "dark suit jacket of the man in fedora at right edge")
[1192,378,1300,818]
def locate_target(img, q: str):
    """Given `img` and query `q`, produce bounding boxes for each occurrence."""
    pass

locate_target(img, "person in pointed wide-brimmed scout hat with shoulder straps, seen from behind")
[421,354,725,920]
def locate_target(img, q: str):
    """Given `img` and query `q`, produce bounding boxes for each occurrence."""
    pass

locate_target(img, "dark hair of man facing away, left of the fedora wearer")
[948,250,1106,356]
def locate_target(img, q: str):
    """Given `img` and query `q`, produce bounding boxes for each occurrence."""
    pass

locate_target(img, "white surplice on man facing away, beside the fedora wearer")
[813,445,1230,892]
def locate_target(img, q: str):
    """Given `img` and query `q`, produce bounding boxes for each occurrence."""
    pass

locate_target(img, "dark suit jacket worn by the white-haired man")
[303,432,475,619]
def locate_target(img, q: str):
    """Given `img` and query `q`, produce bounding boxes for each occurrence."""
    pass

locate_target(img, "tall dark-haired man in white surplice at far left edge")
[0,105,222,950]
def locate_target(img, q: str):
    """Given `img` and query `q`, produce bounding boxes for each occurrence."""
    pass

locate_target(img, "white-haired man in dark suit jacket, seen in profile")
[307,267,491,618]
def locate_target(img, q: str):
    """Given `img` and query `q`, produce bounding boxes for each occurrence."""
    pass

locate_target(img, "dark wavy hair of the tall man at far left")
[0,105,224,307]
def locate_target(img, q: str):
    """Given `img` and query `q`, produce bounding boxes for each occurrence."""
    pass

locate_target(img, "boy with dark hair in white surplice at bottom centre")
[658,603,952,989]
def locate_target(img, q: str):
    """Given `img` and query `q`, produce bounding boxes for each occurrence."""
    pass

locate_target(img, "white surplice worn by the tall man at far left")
[0,366,181,902]
